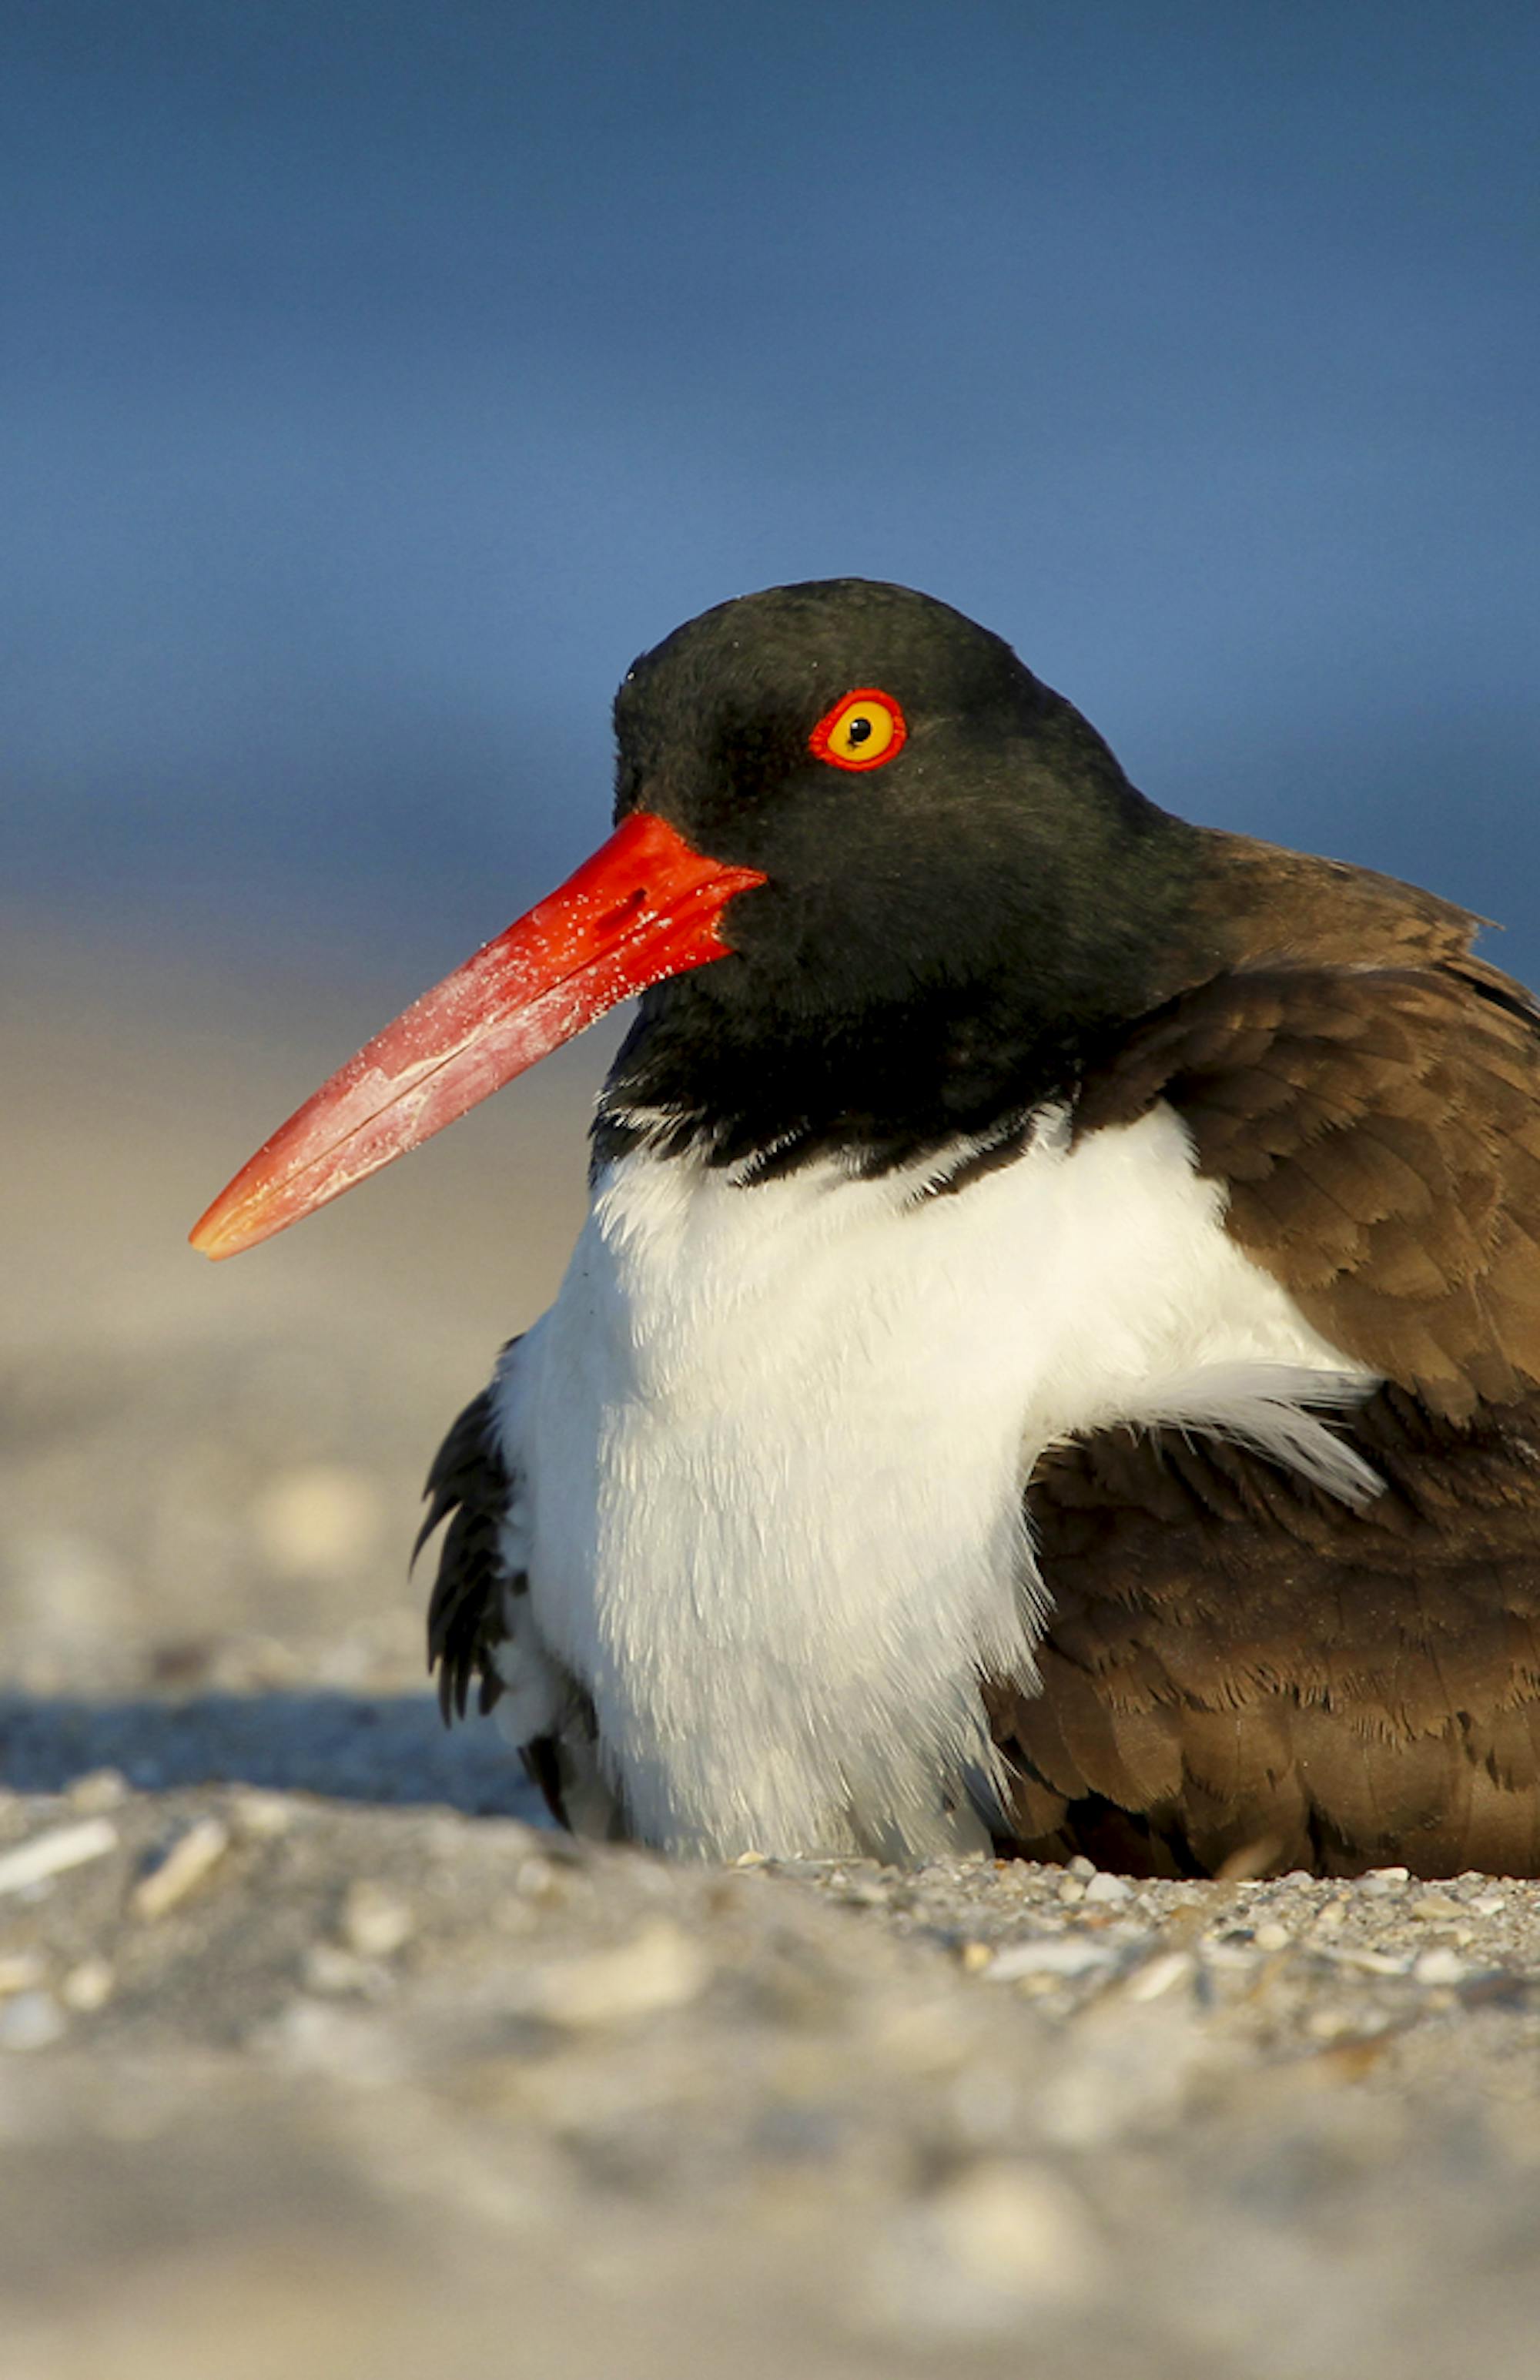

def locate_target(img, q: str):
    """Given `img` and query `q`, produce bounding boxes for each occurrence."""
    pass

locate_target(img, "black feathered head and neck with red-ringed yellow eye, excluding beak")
[598,578,1197,1171]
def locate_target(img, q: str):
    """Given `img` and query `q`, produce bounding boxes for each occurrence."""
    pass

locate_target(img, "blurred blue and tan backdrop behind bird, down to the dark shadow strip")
[0,0,1540,1685]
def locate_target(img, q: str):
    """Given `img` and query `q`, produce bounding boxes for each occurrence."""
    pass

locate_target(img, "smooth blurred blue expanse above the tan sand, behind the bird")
[0,0,1540,990]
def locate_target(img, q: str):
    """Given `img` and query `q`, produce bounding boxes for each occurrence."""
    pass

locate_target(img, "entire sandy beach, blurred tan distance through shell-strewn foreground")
[0,926,1540,2380]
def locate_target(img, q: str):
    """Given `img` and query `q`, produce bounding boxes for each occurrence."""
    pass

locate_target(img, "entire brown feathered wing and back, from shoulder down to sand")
[993,937,1540,1873]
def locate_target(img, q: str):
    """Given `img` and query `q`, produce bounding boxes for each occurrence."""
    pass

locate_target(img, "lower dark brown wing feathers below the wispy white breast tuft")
[990,1387,1540,1876]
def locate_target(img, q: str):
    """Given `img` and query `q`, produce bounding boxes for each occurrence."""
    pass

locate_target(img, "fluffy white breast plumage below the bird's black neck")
[497,1109,1374,1859]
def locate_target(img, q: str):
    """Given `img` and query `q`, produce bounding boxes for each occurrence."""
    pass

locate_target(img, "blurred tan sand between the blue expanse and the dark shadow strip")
[0,928,617,1695]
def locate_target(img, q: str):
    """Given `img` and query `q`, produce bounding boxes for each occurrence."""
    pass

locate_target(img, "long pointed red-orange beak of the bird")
[190,812,764,1257]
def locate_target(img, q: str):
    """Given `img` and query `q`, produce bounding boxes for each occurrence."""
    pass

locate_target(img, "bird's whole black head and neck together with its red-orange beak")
[192,578,1195,1257]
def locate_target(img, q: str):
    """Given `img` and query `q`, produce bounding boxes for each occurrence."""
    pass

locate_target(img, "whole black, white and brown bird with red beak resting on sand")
[192,578,1540,1876]
